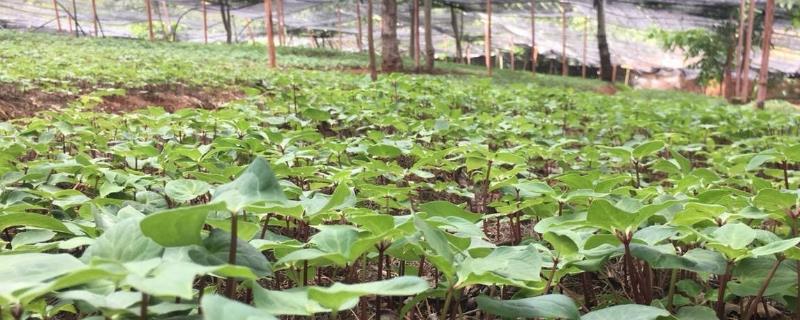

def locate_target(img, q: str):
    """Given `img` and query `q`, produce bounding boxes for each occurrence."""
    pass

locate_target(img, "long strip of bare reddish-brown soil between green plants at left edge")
[0,83,244,121]
